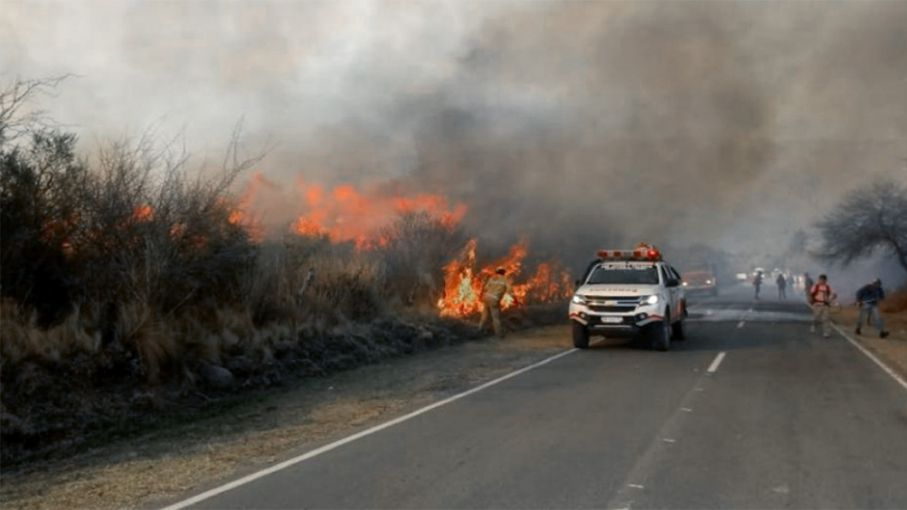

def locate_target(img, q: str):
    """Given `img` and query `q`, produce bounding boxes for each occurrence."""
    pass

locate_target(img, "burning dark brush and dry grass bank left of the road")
[0,84,570,462]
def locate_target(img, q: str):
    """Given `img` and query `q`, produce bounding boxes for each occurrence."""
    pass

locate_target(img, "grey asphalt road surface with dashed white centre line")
[179,287,907,508]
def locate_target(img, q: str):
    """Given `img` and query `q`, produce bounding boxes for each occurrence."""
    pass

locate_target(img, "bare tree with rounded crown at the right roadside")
[816,179,907,271]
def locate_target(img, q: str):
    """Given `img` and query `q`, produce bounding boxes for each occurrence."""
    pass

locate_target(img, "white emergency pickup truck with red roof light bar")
[570,244,687,351]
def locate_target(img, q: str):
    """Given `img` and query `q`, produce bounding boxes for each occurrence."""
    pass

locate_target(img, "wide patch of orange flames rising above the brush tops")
[291,182,466,249]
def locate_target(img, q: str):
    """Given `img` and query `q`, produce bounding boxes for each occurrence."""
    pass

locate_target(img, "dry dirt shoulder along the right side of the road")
[832,306,907,377]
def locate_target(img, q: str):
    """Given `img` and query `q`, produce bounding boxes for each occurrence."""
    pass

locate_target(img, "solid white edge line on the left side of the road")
[162,342,580,510]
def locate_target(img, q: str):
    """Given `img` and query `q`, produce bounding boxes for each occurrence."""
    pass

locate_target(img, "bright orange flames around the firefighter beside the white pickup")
[437,239,573,318]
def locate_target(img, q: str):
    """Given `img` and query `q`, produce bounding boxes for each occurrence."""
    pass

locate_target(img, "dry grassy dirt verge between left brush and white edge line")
[0,326,572,510]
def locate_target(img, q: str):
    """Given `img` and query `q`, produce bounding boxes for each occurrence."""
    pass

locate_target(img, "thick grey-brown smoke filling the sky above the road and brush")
[0,2,907,270]
